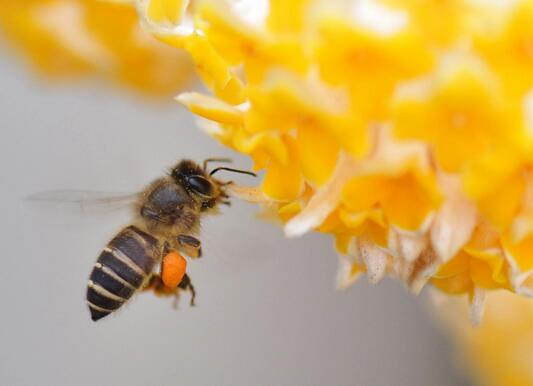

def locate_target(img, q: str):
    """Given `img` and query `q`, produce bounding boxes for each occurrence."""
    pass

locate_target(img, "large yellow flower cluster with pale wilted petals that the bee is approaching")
[138,0,533,321]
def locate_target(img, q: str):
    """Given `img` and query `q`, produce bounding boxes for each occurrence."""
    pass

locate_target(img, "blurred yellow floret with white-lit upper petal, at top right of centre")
[312,2,434,121]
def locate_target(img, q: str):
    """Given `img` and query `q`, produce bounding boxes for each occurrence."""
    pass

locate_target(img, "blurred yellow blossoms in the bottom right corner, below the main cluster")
[436,291,533,386]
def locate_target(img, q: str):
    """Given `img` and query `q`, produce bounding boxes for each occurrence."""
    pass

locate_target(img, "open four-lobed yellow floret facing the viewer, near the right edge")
[393,54,521,173]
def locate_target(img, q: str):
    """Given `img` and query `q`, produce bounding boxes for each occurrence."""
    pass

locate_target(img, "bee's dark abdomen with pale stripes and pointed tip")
[87,226,159,321]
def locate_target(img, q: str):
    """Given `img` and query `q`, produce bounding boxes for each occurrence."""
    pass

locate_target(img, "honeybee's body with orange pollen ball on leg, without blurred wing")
[30,158,255,321]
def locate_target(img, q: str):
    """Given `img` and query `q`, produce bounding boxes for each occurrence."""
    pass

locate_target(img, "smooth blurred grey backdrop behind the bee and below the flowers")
[0,52,468,386]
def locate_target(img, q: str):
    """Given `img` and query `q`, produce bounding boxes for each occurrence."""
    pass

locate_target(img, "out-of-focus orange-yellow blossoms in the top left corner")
[0,0,193,95]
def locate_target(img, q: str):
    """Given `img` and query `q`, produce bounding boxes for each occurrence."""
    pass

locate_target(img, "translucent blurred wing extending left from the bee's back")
[26,189,137,211]
